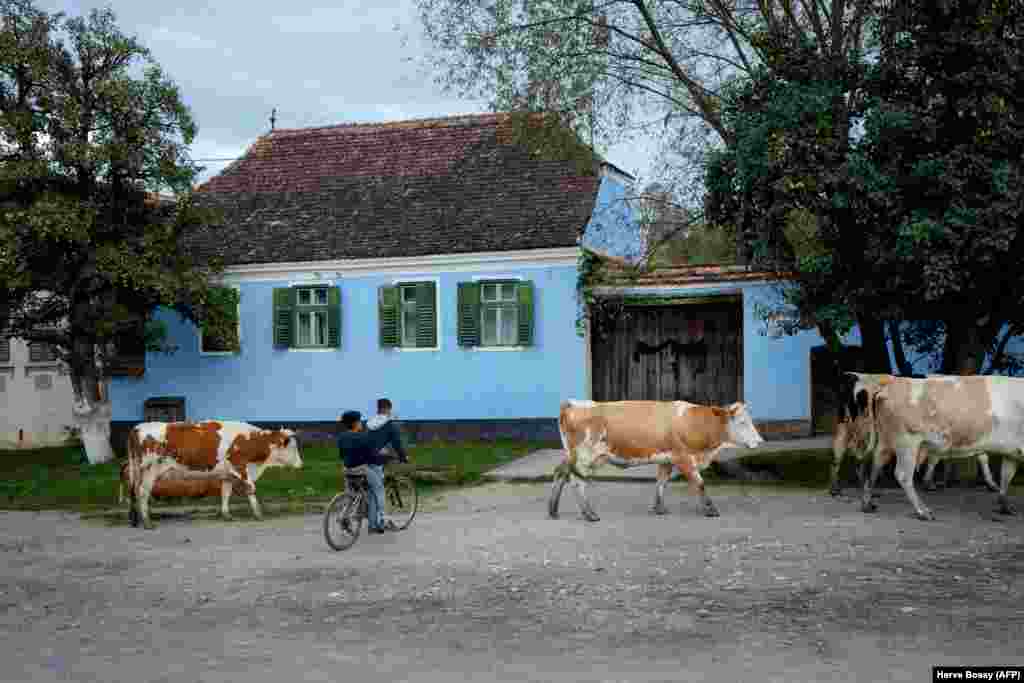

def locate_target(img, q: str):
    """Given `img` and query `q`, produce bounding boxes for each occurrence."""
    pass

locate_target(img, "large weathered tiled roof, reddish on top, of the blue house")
[186,114,600,264]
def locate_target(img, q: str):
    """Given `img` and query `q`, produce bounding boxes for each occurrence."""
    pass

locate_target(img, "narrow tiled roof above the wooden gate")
[590,250,788,287]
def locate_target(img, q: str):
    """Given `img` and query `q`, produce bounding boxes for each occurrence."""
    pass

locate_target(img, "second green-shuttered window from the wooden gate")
[378,281,437,348]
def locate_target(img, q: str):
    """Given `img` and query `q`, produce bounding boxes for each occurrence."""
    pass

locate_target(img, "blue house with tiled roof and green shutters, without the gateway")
[111,115,642,438]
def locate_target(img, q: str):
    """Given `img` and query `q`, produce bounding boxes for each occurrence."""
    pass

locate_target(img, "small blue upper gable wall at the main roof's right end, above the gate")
[582,173,643,260]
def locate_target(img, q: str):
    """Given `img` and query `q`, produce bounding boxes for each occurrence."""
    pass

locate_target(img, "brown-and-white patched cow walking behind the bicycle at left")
[128,420,302,528]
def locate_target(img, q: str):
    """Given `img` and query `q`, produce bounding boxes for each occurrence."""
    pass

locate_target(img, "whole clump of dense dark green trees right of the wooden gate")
[708,1,1024,374]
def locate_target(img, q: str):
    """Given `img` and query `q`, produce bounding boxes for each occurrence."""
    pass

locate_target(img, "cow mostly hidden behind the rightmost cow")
[829,373,998,496]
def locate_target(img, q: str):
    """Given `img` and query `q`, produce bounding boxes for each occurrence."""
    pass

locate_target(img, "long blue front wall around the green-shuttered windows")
[111,265,586,421]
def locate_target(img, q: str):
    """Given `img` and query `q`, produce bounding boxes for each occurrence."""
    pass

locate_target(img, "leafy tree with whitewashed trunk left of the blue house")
[0,0,227,463]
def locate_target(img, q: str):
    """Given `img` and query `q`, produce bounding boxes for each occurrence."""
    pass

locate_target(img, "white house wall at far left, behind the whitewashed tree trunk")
[0,339,73,449]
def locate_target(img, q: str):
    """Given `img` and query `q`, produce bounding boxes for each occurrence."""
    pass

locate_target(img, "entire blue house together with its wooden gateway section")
[111,115,1007,446]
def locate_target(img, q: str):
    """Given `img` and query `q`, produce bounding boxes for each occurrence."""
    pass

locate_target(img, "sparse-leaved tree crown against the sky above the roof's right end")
[416,0,880,240]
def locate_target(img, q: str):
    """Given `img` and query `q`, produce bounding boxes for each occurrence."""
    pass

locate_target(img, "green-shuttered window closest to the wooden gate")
[459,280,534,348]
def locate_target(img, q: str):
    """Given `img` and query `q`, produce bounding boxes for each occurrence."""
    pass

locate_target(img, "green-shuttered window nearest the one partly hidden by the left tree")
[273,285,341,349]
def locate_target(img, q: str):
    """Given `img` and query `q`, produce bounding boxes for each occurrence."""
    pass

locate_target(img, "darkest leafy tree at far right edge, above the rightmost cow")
[855,0,1024,374]
